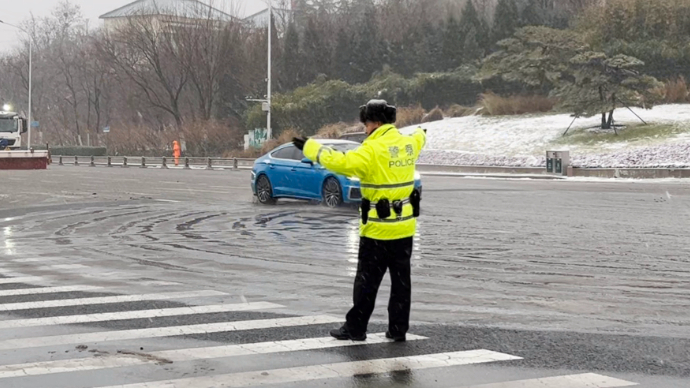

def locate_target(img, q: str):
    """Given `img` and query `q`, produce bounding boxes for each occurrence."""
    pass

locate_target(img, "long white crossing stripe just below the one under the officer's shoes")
[95,349,521,388]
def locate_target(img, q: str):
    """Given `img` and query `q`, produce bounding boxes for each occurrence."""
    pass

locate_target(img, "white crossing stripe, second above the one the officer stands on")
[0,302,284,329]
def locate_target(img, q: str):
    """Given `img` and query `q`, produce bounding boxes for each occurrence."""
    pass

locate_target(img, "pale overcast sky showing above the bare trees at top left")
[0,0,266,52]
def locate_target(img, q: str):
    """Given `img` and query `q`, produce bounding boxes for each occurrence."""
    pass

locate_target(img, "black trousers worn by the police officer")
[346,237,413,335]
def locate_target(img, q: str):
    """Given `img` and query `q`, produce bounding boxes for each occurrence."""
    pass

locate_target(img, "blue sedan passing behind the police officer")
[252,140,421,207]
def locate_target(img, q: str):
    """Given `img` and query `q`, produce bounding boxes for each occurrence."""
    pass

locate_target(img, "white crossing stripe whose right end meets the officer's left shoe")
[0,315,342,350]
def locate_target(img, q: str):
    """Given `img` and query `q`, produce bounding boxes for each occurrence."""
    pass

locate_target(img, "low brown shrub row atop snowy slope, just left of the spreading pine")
[479,92,556,116]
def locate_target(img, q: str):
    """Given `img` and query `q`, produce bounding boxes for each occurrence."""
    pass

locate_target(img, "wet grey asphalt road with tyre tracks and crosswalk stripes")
[0,167,690,388]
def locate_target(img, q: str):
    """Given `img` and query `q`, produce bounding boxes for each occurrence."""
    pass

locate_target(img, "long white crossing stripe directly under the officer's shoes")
[0,333,426,379]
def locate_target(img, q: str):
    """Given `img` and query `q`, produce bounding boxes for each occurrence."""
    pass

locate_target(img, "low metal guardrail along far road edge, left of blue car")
[51,155,256,170]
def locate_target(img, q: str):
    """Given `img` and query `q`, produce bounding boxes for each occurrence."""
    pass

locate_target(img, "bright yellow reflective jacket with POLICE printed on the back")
[304,125,426,240]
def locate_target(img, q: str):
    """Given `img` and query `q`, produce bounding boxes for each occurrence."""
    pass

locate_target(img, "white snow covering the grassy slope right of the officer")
[402,105,690,167]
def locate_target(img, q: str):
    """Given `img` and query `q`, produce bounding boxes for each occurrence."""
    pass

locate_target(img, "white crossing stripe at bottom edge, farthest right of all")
[460,373,638,388]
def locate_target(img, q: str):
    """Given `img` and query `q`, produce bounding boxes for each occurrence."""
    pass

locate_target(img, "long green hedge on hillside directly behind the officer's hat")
[245,67,484,137]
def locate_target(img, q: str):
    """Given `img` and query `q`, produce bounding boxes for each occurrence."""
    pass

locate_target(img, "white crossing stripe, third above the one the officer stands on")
[0,291,227,311]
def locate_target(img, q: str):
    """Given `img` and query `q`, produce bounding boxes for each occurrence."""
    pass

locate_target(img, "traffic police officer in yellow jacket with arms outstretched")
[294,100,426,342]
